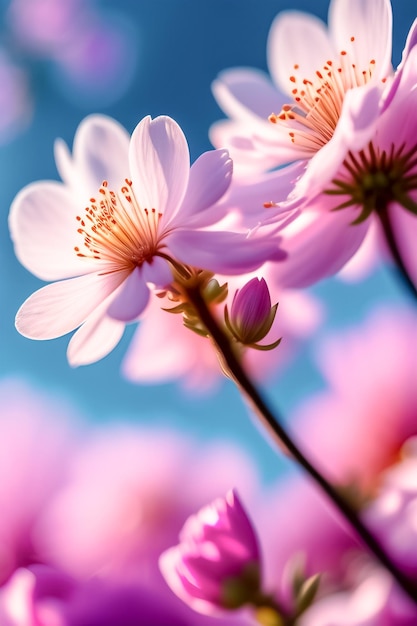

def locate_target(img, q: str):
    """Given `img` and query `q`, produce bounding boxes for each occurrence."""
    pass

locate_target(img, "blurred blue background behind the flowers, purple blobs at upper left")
[0,0,415,481]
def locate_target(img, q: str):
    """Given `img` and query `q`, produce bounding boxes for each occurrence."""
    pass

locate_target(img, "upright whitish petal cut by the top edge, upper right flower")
[329,0,392,78]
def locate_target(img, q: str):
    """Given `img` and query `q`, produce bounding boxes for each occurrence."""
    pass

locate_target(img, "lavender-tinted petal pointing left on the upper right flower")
[211,68,286,122]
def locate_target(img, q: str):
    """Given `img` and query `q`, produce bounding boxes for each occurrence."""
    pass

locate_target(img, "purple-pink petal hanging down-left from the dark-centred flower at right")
[275,196,368,288]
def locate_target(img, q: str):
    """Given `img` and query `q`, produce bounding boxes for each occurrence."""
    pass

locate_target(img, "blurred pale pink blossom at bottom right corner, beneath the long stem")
[299,567,417,626]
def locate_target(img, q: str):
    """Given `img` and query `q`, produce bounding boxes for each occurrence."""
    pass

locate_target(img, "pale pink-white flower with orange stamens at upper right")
[210,0,392,174]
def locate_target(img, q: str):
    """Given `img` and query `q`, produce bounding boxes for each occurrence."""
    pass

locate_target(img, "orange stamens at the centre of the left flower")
[74,179,162,271]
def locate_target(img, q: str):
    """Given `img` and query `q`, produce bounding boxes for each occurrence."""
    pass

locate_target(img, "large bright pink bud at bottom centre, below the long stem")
[159,490,260,615]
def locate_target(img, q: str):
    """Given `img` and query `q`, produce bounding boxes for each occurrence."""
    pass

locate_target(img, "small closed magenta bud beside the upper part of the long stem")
[224,278,281,349]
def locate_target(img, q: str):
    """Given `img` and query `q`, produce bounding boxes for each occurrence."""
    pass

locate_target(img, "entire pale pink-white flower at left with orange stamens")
[10,115,284,364]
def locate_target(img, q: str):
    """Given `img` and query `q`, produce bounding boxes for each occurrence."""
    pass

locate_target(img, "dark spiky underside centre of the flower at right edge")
[325,142,417,224]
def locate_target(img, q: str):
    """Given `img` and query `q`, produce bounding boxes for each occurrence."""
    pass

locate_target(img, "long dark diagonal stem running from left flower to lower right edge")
[187,287,417,604]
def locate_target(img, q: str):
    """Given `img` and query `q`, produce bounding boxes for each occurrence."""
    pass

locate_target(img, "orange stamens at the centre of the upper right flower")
[269,37,375,155]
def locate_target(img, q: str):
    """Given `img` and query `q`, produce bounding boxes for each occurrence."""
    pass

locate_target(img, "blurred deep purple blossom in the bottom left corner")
[0,565,192,626]
